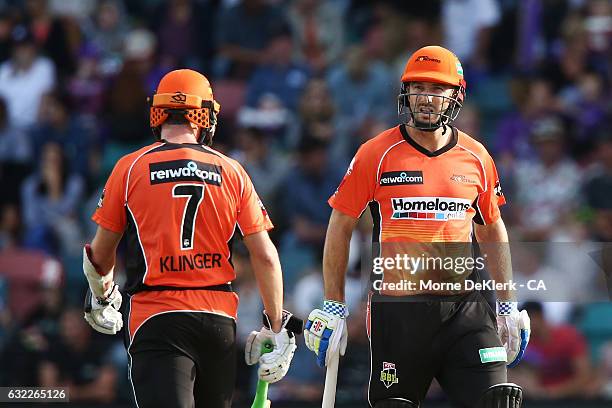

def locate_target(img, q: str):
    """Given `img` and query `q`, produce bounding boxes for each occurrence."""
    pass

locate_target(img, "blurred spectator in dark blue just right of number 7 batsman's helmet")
[246,32,310,110]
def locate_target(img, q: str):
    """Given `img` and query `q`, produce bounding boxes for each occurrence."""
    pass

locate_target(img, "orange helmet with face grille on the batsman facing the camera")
[398,45,467,131]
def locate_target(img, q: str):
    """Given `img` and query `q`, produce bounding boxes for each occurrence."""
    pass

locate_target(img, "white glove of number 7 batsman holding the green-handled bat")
[244,310,297,383]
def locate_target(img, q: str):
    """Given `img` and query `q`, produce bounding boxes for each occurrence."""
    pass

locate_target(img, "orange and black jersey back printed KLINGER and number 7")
[92,141,272,340]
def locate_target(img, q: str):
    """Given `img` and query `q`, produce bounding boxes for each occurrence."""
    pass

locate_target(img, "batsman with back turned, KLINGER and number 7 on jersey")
[83,69,296,408]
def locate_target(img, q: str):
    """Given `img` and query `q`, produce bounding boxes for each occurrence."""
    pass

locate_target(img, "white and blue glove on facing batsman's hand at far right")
[497,301,531,368]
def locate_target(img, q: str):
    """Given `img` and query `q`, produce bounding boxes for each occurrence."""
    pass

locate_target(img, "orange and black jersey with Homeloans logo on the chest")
[329,126,505,296]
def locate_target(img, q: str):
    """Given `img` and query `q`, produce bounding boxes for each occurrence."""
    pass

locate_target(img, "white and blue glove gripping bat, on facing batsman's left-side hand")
[304,300,348,367]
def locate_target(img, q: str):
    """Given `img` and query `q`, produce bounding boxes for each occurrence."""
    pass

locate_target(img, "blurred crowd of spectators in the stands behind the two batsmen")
[0,0,612,406]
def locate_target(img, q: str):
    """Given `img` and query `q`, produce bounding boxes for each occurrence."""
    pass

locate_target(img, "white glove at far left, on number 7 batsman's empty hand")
[84,285,123,334]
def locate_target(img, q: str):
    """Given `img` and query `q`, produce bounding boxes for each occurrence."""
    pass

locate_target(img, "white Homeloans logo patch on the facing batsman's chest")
[391,197,471,221]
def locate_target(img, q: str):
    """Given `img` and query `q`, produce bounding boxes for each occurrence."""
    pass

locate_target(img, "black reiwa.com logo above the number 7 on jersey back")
[149,160,222,186]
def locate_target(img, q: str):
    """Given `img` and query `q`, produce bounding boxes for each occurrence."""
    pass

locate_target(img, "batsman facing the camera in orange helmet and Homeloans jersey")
[304,46,529,408]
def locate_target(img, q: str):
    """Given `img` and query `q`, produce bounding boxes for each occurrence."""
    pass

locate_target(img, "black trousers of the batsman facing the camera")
[368,292,507,408]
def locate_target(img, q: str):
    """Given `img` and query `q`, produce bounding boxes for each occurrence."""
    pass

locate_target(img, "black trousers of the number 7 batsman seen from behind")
[128,312,236,408]
